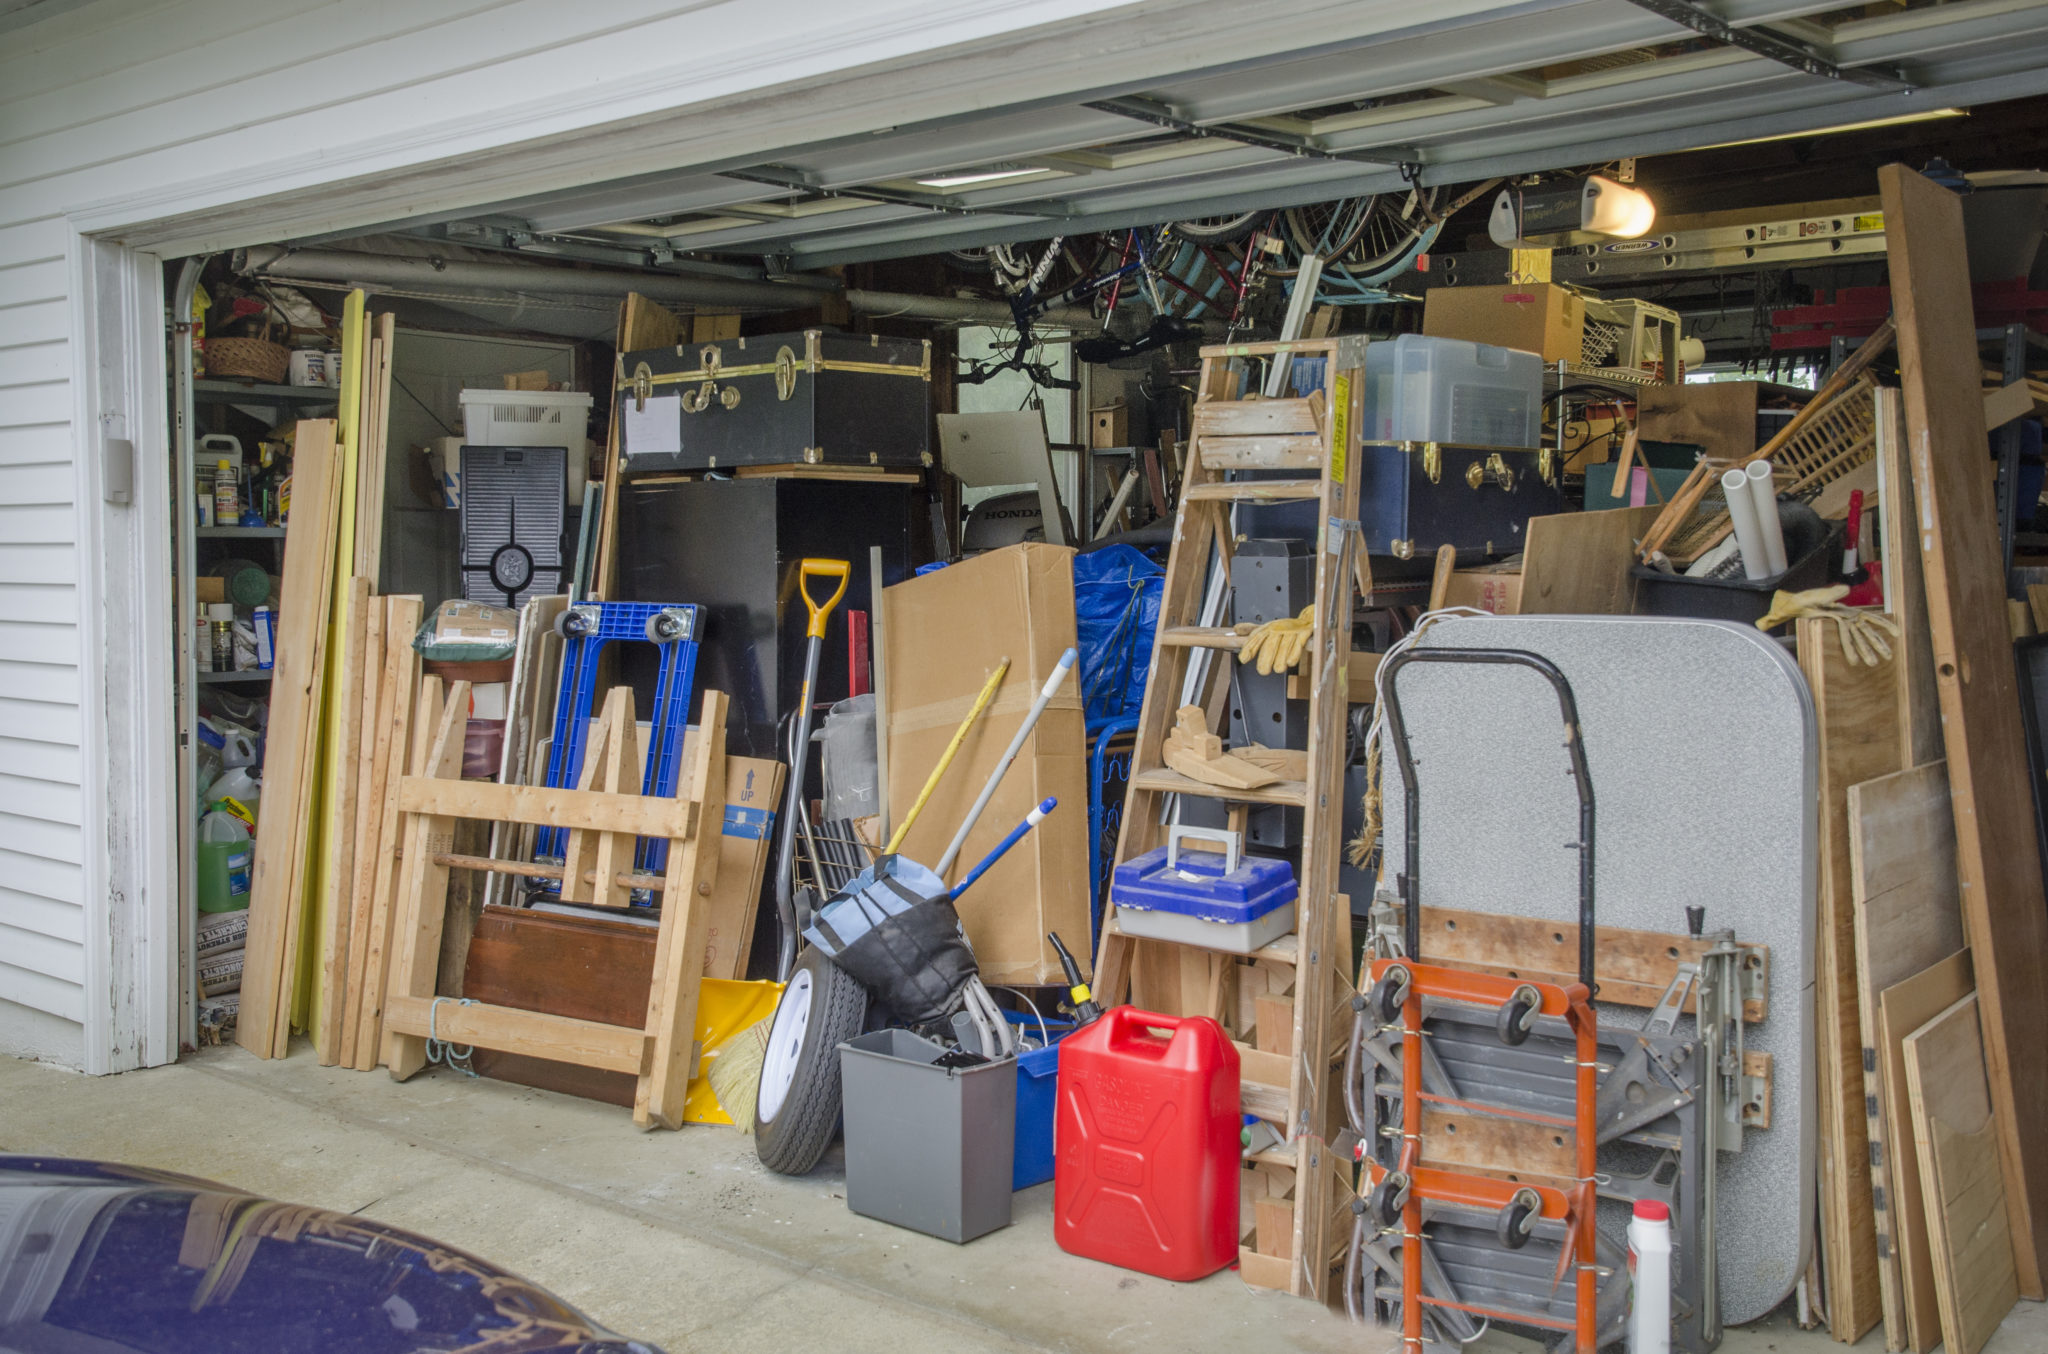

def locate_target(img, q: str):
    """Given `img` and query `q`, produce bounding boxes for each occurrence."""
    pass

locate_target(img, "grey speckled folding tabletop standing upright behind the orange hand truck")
[1384,617,1817,1323]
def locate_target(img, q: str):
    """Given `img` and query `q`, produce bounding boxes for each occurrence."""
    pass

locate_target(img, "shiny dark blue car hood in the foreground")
[0,1155,659,1354]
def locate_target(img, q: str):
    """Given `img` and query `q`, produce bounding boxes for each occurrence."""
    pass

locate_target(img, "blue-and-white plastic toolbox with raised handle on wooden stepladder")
[1110,823,1300,955]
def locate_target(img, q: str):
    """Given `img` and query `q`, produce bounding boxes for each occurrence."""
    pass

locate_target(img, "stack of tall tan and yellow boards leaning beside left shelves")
[236,291,397,1057]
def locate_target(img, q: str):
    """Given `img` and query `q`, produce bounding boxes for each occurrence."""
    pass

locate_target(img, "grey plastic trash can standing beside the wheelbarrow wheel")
[840,1030,1018,1241]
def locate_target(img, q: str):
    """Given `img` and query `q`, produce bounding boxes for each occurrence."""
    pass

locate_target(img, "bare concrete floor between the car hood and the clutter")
[0,1045,2048,1354]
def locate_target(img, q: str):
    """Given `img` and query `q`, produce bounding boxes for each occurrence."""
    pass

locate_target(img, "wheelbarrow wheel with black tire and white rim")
[754,948,868,1176]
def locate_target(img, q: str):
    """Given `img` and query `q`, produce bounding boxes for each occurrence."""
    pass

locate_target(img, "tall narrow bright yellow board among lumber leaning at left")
[291,291,369,1030]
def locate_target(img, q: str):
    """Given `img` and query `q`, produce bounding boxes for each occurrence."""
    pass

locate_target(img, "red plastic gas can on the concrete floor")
[1053,1006,1243,1280]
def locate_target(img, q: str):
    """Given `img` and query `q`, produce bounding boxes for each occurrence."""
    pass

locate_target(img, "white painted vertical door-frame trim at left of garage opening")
[66,225,180,1073]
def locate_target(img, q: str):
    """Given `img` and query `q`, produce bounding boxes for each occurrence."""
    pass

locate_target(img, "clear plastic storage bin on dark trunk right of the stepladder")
[1366,334,1542,447]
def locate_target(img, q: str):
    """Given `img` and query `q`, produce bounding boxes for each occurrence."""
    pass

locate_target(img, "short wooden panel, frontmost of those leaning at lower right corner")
[1905,993,2019,1354]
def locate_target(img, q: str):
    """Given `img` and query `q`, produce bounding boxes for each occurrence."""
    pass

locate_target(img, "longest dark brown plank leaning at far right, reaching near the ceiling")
[1878,164,2048,1299]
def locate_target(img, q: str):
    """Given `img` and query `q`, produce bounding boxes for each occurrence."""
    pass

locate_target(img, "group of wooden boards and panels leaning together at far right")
[1798,166,2048,1354]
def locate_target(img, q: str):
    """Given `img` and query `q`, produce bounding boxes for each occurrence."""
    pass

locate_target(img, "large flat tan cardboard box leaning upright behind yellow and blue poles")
[883,545,1090,983]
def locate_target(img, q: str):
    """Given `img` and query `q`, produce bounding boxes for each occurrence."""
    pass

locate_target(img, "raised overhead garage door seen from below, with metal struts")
[327,0,2048,270]
